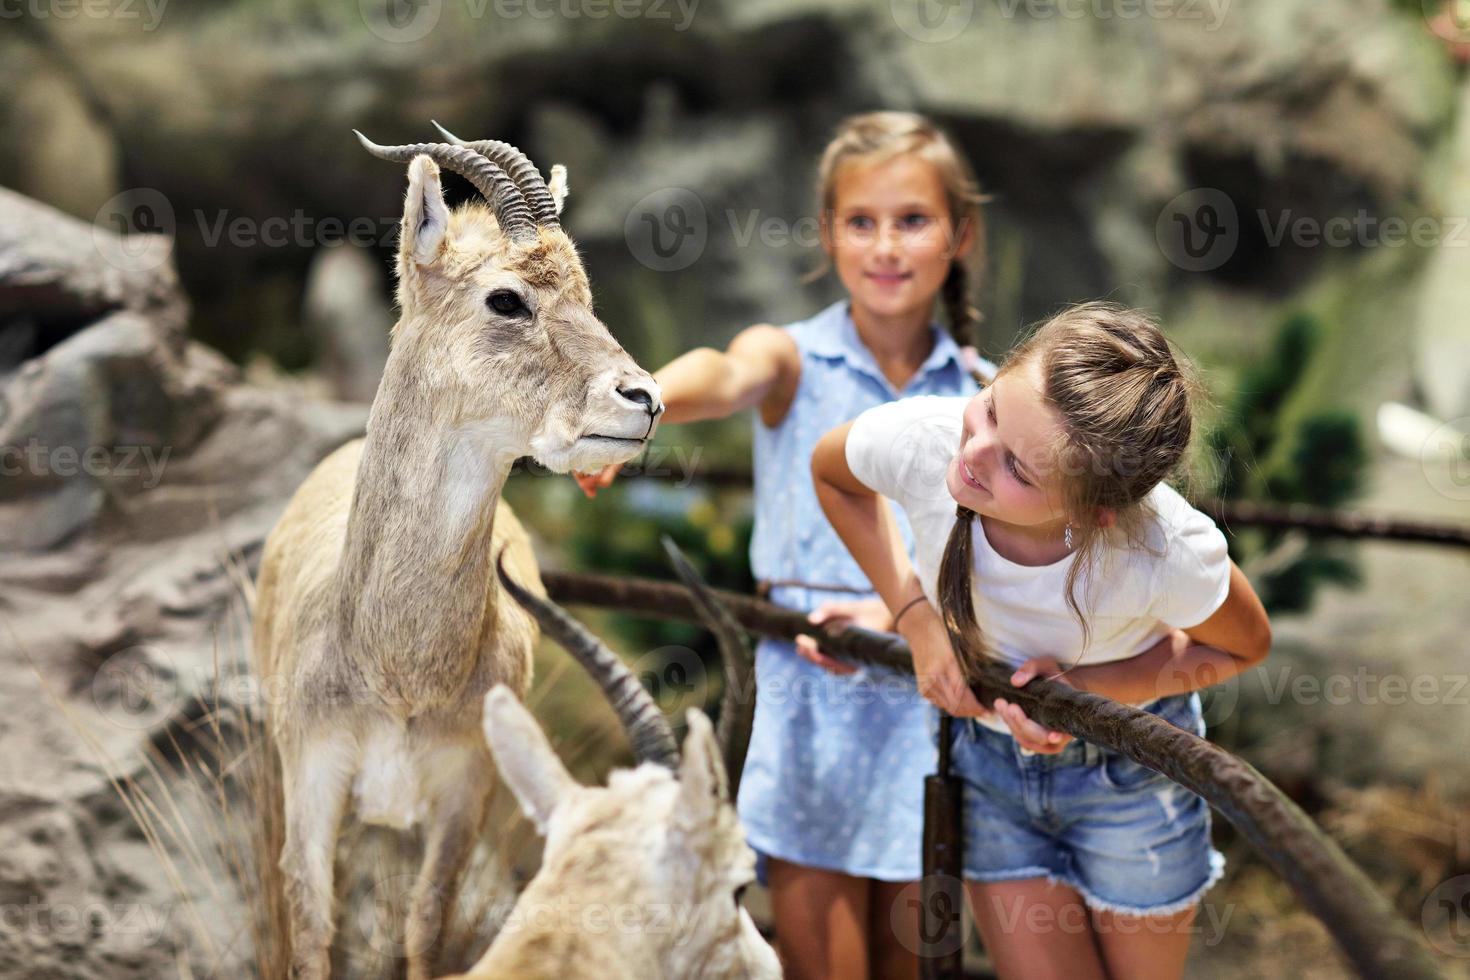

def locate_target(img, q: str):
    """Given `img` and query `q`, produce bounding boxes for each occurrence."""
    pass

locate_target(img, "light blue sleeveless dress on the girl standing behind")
[736,300,978,882]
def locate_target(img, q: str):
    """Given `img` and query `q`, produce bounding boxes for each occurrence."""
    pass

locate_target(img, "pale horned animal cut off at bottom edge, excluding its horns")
[449,686,781,980]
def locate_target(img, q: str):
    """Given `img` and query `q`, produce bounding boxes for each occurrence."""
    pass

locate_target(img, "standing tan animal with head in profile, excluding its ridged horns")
[253,141,663,980]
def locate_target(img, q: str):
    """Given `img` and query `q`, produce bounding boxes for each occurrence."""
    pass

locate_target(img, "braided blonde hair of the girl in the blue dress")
[809,112,986,345]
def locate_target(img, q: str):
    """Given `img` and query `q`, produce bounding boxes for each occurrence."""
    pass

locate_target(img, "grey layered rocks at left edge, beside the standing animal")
[0,191,366,980]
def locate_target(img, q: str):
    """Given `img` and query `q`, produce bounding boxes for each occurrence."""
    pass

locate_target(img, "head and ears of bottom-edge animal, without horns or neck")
[485,686,781,980]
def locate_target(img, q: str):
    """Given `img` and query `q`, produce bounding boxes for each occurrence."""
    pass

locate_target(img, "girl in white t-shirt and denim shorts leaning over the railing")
[811,303,1270,980]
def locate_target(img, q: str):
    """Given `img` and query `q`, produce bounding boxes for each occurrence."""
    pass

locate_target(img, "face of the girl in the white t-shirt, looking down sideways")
[944,359,1067,527]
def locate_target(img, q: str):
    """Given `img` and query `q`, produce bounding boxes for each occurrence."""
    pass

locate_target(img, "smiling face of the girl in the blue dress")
[822,153,975,329]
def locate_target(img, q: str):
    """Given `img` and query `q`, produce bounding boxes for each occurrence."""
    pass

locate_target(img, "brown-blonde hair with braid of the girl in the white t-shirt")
[939,303,1204,680]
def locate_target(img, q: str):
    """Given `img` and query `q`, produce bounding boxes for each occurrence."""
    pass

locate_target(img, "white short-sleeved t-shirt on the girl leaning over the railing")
[847,397,1230,730]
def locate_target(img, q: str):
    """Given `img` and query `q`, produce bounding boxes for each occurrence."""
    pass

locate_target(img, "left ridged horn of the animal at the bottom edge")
[495,548,679,773]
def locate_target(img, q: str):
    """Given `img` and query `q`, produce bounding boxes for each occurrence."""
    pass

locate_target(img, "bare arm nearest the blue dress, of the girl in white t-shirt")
[811,422,986,717]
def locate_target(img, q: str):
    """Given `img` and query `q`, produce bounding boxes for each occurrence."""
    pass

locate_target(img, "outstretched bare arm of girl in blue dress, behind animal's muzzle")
[573,323,801,497]
